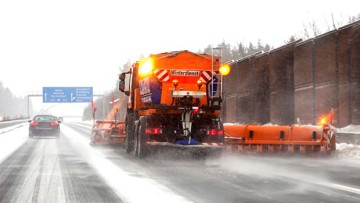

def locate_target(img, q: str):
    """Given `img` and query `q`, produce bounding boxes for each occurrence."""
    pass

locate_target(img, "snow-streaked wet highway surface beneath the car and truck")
[0,123,360,202]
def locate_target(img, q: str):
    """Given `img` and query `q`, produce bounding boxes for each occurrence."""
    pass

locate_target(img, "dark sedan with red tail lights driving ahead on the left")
[29,115,60,137]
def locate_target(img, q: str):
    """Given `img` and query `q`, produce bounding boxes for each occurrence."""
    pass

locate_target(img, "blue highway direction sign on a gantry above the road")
[43,87,93,103]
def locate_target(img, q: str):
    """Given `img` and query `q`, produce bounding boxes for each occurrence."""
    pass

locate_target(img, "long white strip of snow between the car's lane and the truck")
[61,126,191,202]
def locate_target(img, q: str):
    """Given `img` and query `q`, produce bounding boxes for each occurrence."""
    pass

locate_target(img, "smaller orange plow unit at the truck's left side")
[90,120,126,145]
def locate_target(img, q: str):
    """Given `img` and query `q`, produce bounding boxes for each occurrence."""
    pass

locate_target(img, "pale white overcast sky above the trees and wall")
[0,0,360,116]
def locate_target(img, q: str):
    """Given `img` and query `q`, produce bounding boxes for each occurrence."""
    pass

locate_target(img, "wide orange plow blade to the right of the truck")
[224,124,336,155]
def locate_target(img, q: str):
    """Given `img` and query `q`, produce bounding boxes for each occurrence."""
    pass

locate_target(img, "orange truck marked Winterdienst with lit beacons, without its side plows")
[119,51,230,157]
